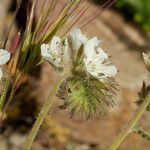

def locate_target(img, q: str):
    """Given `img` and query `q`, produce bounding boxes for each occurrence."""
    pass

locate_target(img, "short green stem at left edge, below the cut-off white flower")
[0,80,10,112]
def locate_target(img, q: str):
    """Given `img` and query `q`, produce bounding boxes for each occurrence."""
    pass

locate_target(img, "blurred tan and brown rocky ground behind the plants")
[0,0,150,150]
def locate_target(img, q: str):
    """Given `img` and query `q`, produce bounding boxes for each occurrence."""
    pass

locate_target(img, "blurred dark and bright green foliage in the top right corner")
[116,0,150,31]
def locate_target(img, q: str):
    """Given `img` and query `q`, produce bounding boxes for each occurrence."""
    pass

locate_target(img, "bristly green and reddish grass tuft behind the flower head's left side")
[17,0,81,74]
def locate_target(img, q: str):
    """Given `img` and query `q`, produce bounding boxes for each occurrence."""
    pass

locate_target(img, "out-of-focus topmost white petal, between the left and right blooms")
[70,28,88,51]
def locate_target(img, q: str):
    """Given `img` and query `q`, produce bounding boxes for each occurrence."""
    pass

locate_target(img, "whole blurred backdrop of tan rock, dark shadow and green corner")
[0,0,150,150]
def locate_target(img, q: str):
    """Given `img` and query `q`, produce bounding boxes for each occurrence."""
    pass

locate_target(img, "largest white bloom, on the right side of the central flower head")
[84,37,117,79]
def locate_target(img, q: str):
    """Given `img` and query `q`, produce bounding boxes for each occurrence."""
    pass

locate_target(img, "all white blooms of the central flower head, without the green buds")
[41,28,117,80]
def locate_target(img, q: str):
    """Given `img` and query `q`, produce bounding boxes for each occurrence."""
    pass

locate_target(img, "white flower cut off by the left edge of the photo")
[0,49,10,79]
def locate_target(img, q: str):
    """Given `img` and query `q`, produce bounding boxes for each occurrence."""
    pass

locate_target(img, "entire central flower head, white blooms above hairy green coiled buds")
[41,28,117,118]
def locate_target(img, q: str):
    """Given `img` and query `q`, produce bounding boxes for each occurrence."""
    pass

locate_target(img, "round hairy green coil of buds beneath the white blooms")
[58,72,116,119]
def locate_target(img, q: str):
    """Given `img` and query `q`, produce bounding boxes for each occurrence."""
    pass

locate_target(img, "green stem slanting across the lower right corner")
[109,94,150,150]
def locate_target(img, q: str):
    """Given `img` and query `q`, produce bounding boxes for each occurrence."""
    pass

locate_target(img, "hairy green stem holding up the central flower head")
[23,76,64,150]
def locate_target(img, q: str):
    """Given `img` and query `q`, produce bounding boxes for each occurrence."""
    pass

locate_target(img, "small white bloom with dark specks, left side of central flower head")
[41,36,68,68]
